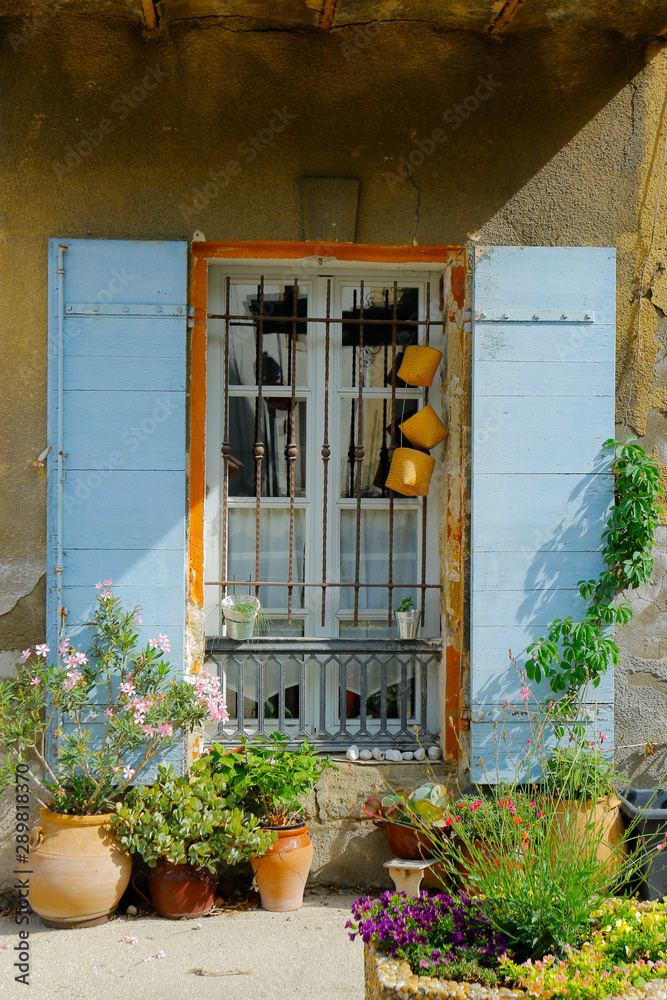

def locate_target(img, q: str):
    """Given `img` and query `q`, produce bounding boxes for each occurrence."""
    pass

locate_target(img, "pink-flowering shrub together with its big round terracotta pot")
[0,580,228,927]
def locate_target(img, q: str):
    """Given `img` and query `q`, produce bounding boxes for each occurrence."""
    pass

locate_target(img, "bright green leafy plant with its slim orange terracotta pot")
[195,733,333,911]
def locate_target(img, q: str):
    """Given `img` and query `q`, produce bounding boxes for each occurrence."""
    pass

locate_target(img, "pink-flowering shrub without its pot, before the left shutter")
[0,580,228,815]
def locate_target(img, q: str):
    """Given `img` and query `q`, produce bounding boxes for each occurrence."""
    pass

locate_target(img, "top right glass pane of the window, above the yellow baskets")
[341,281,423,388]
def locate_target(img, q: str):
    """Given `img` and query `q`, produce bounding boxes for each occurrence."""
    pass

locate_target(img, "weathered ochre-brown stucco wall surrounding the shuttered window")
[0,13,667,882]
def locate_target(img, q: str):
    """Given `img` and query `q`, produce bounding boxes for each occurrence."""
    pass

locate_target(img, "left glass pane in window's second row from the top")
[229,396,306,497]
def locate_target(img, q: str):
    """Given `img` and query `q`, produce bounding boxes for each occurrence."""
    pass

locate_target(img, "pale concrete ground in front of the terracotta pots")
[0,889,364,1000]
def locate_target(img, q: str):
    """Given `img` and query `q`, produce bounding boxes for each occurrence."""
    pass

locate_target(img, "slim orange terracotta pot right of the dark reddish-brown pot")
[250,823,313,911]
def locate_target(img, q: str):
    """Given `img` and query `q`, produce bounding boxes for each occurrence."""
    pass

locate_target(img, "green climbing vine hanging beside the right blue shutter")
[526,437,663,708]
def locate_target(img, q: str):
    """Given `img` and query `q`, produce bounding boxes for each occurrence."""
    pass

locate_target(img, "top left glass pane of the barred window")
[223,284,308,385]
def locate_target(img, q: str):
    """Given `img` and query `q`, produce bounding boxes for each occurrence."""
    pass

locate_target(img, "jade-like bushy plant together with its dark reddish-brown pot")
[111,767,276,920]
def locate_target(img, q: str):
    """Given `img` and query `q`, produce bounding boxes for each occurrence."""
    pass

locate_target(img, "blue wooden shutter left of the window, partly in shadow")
[47,240,187,744]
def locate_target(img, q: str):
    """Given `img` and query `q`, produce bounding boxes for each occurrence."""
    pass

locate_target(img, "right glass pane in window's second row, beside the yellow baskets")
[340,398,421,497]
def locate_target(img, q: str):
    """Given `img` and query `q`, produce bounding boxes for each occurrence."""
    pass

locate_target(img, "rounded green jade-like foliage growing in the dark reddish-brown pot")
[111,766,276,872]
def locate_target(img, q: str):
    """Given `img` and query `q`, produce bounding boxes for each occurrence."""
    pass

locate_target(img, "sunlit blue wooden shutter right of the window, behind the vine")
[471,247,615,781]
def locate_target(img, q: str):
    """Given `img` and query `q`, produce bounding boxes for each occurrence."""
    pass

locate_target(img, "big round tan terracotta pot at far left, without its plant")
[29,808,132,927]
